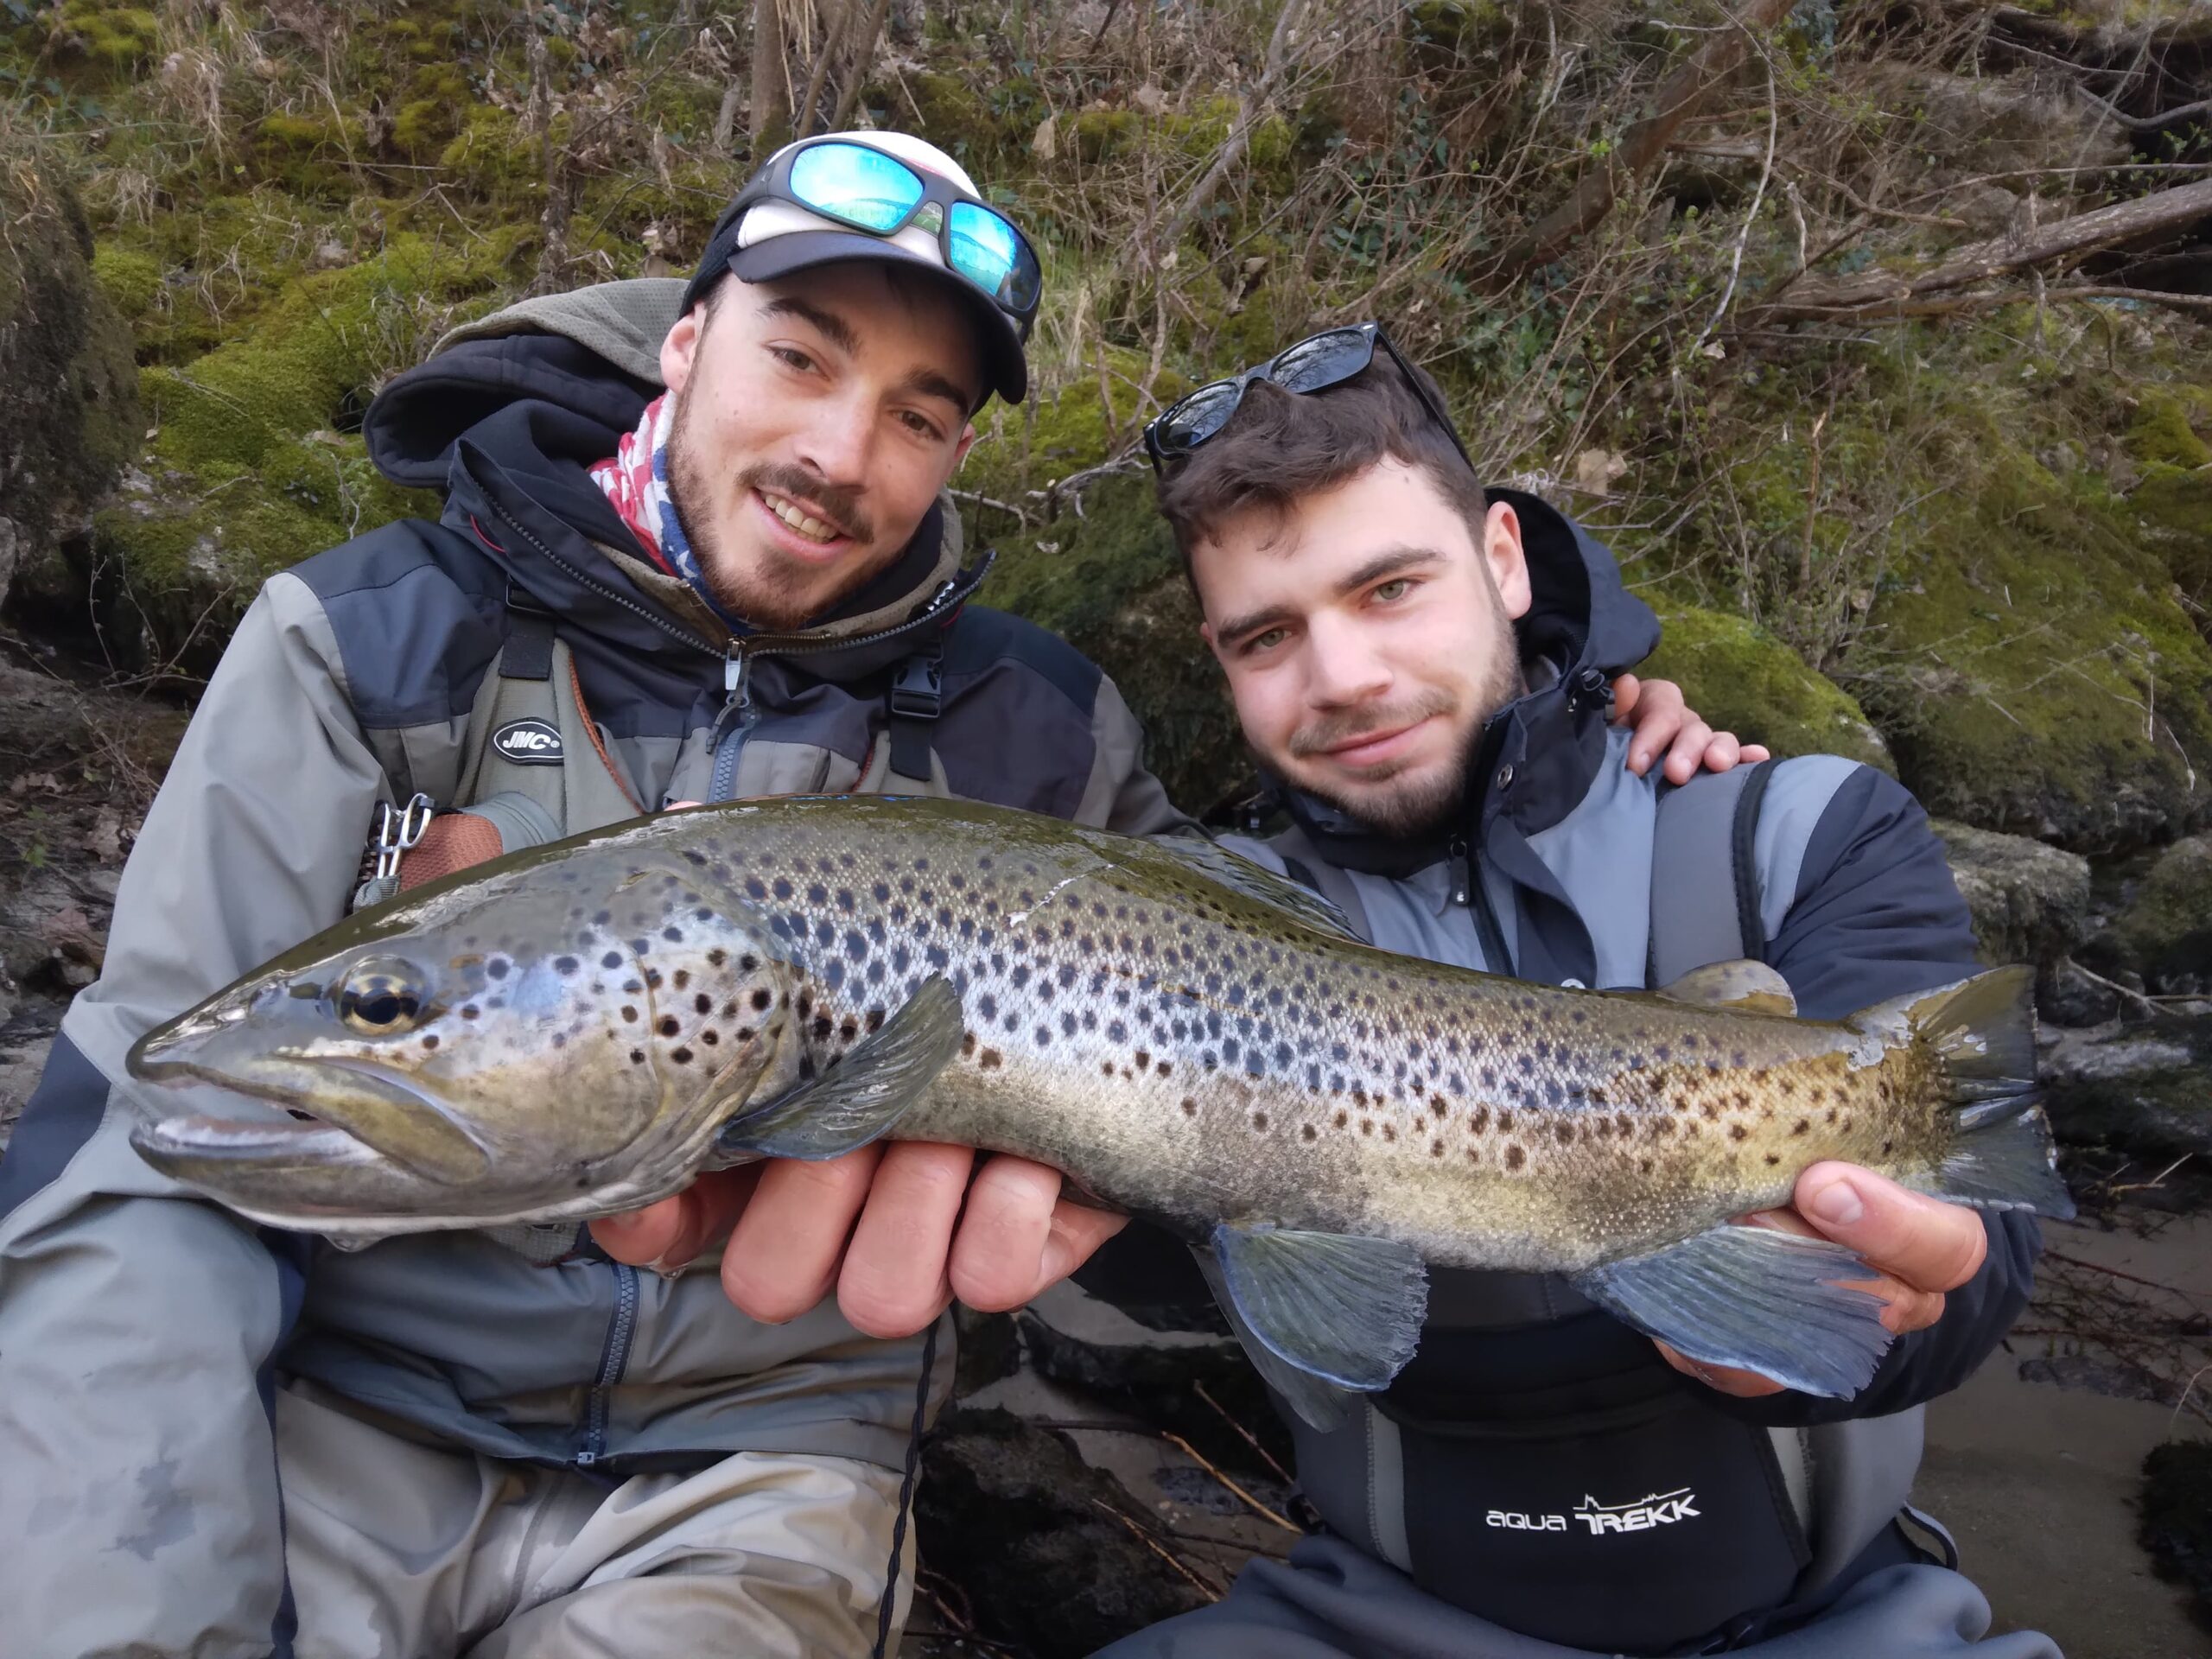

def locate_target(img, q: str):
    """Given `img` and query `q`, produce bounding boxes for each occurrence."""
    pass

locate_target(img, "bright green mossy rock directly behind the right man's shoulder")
[1637,600,1897,772]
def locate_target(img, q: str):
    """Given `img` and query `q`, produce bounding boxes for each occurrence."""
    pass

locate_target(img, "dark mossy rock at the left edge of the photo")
[0,150,142,608]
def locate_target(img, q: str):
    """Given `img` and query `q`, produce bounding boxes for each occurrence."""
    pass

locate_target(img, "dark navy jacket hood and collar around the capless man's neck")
[1269,489,1659,876]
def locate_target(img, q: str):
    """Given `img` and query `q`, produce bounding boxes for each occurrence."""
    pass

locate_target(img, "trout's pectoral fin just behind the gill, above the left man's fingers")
[715,978,967,1161]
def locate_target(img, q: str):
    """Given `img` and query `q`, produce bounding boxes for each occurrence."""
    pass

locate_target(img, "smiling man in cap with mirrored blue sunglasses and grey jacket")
[0,135,1703,1659]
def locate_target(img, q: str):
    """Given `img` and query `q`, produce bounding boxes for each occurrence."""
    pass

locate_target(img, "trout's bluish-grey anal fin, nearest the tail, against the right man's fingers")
[1575,1224,1889,1400]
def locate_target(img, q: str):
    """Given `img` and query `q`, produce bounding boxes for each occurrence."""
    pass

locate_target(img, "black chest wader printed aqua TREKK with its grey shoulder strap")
[1269,761,1955,1655]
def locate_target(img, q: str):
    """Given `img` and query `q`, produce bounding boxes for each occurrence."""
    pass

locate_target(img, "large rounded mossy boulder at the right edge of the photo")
[1865,454,2212,852]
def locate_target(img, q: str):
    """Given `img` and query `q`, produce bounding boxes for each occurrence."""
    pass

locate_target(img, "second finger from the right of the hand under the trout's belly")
[836,1141,976,1336]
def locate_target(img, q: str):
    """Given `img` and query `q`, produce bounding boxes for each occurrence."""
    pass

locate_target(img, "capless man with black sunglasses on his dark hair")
[1102,323,2055,1659]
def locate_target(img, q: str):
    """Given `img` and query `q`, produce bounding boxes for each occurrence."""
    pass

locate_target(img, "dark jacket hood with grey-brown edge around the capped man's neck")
[363,276,980,666]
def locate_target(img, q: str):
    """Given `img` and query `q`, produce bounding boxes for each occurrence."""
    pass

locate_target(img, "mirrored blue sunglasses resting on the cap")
[716,139,1044,336]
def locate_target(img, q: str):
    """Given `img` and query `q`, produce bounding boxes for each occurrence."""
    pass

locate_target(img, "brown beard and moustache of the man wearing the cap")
[668,385,880,631]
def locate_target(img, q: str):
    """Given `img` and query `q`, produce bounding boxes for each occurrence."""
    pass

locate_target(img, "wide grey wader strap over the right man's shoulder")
[1646,761,1774,987]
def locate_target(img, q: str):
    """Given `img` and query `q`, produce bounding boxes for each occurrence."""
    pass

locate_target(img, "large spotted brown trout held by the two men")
[128,797,2070,1421]
